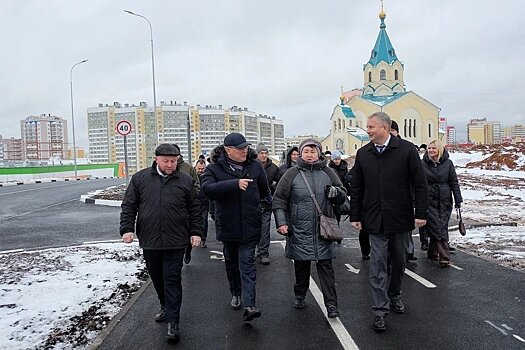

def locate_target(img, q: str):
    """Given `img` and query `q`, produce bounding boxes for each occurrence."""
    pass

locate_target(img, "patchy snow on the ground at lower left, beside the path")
[0,243,146,349]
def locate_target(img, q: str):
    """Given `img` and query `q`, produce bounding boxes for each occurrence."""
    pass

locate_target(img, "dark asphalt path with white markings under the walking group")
[99,217,525,350]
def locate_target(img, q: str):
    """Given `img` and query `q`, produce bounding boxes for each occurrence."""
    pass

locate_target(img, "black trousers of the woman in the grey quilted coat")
[293,259,337,306]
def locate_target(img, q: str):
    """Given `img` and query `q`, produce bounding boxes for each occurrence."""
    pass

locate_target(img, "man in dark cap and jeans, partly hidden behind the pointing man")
[255,143,279,265]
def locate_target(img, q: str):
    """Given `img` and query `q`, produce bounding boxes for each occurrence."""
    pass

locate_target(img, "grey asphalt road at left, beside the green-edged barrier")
[0,179,124,251]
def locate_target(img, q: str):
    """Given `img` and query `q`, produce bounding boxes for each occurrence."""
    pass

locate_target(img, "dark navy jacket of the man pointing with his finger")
[201,147,270,243]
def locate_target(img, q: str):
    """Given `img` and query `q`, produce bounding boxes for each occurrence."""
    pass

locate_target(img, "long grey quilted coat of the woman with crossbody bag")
[272,158,346,261]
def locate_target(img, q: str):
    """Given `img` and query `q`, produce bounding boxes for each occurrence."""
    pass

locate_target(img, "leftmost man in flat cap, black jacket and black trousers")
[120,143,202,342]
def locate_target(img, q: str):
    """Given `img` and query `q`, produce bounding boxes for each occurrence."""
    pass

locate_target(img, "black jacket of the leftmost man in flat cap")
[120,162,203,250]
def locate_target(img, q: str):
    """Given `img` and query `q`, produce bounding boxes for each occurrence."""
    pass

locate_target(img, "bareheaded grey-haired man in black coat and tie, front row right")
[350,112,428,332]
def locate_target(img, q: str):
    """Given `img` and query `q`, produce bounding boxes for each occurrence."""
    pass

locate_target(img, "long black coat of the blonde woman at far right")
[422,150,463,241]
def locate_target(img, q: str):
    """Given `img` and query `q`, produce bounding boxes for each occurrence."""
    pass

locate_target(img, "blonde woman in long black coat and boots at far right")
[423,140,463,267]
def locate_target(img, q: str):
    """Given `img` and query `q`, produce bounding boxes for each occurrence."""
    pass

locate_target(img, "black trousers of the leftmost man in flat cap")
[143,249,184,323]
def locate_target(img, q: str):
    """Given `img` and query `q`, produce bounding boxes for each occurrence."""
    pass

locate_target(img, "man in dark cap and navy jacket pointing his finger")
[202,133,271,321]
